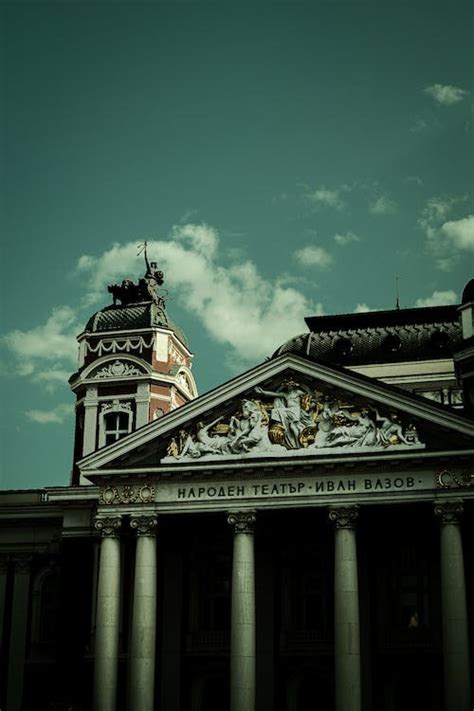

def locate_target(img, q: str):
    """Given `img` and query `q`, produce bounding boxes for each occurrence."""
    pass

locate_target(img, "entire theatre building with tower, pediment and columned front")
[0,263,474,711]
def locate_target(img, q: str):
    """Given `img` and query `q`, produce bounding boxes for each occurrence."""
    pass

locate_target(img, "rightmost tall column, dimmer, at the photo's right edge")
[434,500,472,711]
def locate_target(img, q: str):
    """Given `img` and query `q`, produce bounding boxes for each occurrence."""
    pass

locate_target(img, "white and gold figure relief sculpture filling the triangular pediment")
[164,378,425,462]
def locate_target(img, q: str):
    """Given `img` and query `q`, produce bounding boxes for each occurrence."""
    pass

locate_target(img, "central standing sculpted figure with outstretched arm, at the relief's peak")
[255,380,314,449]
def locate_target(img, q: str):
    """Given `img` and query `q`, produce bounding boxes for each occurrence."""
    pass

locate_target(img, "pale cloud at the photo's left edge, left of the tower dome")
[2,306,81,380]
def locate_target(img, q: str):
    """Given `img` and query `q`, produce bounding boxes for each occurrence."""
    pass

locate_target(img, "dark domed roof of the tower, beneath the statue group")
[84,301,188,347]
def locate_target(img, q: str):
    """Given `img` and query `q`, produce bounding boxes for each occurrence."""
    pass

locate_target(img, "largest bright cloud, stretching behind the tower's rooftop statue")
[77,224,321,363]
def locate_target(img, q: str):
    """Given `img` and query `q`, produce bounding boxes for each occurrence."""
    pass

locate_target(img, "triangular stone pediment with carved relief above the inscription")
[80,355,474,476]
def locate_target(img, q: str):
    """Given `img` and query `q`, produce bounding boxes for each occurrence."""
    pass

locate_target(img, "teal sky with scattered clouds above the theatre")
[0,0,474,489]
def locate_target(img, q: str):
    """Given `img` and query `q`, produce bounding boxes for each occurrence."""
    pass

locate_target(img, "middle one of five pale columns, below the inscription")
[227,511,255,711]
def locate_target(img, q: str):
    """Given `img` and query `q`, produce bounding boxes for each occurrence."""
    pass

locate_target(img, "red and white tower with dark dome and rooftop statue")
[69,243,197,484]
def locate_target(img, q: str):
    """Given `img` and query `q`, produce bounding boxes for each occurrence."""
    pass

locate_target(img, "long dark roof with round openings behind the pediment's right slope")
[272,305,463,366]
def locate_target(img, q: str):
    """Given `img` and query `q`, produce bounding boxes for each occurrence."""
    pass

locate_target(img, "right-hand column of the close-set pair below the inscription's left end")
[128,513,157,711]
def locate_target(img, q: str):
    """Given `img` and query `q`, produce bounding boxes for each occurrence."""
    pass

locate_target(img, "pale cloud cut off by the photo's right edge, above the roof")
[418,195,474,271]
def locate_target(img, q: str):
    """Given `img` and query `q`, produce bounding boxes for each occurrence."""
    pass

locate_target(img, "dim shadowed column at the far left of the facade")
[7,555,31,711]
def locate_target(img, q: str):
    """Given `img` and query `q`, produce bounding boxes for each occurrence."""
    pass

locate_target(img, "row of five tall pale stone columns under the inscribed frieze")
[90,500,471,711]
